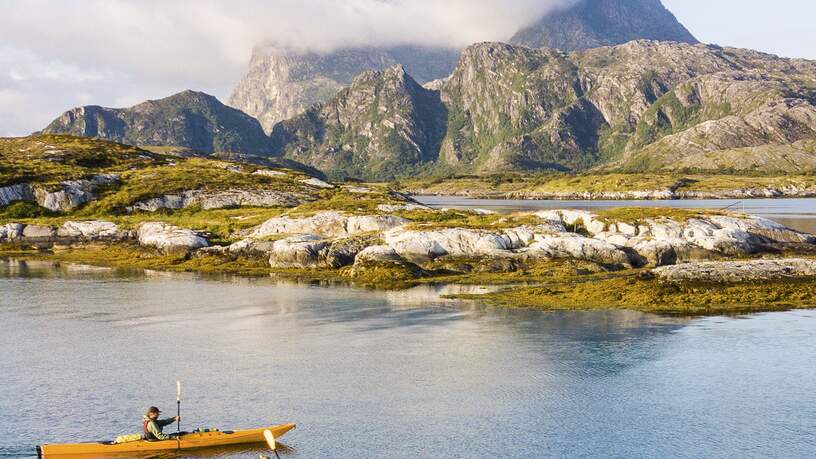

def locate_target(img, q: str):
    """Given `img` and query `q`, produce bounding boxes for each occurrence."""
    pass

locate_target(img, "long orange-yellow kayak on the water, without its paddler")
[37,424,295,458]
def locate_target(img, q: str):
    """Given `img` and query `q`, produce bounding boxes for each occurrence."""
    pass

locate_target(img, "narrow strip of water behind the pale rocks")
[415,196,816,233]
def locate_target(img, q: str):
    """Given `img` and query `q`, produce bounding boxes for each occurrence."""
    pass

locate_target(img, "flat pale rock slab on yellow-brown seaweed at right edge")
[652,258,816,283]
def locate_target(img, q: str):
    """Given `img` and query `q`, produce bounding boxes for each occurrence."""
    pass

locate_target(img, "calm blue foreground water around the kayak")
[0,261,816,458]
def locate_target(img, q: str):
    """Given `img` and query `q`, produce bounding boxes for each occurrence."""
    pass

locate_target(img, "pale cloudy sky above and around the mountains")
[0,0,816,136]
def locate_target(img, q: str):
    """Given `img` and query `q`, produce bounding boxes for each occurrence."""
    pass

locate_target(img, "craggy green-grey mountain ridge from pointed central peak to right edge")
[273,41,816,179]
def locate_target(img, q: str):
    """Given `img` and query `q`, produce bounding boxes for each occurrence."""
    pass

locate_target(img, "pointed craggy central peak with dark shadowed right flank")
[272,65,446,179]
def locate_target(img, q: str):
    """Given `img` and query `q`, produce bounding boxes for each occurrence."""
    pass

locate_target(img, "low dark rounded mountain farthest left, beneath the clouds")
[42,91,272,154]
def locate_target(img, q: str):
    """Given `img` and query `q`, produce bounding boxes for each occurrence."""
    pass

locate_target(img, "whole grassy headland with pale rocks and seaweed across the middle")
[0,136,816,315]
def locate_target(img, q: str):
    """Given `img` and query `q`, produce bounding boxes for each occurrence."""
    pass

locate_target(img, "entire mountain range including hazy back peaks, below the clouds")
[39,0,816,180]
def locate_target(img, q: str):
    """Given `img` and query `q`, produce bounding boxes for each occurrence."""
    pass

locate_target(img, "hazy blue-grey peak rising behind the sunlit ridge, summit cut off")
[510,0,697,51]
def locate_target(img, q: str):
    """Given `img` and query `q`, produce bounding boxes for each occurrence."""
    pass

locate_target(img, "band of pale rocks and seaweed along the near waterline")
[0,204,816,311]
